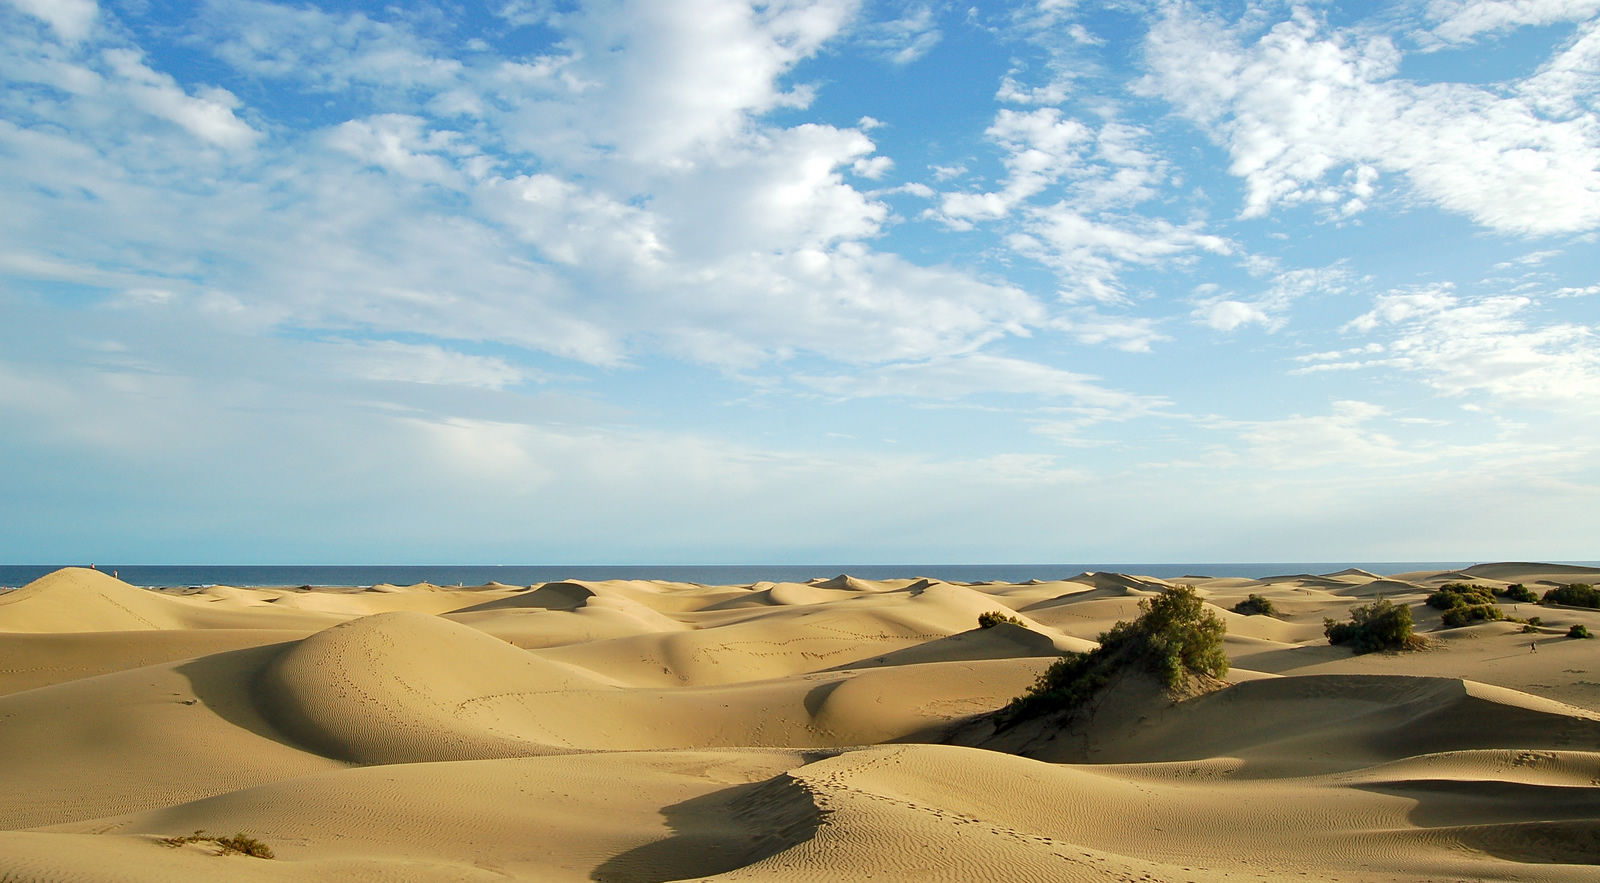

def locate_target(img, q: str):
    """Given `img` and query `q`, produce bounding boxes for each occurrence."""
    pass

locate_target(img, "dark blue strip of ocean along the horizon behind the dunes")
[0,561,1600,589]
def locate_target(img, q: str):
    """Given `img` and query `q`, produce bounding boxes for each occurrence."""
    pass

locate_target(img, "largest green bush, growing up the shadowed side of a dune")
[1000,585,1227,726]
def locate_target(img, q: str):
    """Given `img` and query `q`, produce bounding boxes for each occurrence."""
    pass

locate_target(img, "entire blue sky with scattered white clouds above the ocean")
[0,0,1600,563]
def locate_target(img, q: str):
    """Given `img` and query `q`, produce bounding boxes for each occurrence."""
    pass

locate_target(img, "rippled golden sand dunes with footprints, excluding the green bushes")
[0,563,1600,883]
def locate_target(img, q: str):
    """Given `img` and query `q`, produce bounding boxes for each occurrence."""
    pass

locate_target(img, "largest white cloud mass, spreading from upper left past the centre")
[0,0,1048,382]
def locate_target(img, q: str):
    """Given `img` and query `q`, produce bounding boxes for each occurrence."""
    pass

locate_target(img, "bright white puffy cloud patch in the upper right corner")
[1147,5,1600,234]
